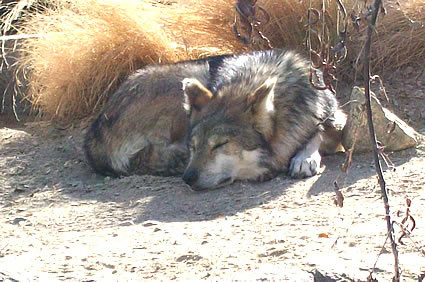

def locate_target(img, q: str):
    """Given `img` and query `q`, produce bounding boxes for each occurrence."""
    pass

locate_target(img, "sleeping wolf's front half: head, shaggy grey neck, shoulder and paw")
[183,50,345,190]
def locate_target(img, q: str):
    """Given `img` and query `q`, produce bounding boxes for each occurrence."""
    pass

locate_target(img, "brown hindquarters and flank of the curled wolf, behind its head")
[84,56,230,176]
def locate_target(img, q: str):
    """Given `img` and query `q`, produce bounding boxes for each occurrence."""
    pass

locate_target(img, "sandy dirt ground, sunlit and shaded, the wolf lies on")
[0,72,425,281]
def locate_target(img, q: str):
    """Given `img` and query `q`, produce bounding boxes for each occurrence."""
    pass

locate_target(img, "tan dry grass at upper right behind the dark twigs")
[262,0,425,76]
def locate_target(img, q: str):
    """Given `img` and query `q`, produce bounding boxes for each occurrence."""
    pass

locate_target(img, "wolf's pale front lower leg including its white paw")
[289,133,322,178]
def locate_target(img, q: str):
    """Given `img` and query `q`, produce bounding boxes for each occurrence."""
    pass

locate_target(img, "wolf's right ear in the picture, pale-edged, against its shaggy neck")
[247,77,277,113]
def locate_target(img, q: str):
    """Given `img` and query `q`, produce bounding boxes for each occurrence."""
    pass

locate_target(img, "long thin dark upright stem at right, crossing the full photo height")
[364,0,400,281]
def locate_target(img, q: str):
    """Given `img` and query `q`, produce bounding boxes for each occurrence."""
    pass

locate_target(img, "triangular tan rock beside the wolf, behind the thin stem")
[342,87,419,152]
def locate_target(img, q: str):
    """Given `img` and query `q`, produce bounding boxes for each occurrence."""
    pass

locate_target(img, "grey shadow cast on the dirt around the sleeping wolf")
[0,118,415,223]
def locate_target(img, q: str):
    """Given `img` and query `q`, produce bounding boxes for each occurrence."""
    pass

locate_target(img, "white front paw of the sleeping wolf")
[289,151,321,178]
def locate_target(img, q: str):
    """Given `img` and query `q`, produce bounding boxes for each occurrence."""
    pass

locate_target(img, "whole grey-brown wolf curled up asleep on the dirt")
[85,50,345,190]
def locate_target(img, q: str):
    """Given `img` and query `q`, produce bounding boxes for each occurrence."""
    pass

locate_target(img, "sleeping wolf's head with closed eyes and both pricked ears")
[183,79,276,190]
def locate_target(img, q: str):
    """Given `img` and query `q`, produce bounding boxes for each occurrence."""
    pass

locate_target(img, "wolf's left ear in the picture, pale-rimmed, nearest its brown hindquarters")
[182,78,213,114]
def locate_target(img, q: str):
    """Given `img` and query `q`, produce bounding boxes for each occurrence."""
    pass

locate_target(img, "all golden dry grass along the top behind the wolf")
[5,0,425,121]
